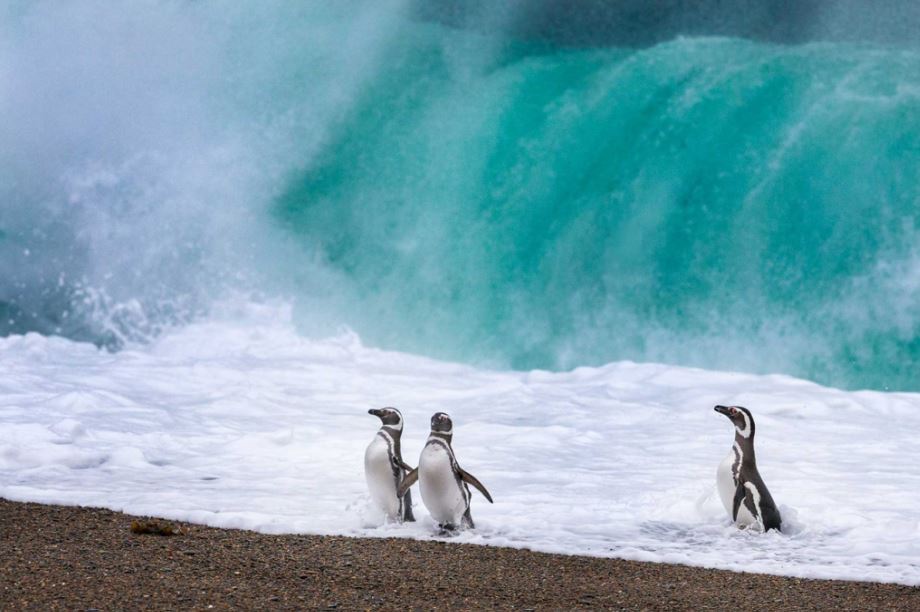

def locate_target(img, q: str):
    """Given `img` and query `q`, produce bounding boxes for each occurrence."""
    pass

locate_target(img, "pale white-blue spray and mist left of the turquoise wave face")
[0,0,399,346]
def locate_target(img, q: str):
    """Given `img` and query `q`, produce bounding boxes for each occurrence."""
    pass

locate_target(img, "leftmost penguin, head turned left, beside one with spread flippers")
[364,408,415,523]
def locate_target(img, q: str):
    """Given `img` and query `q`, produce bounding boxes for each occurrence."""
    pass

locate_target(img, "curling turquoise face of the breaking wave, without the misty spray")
[277,28,920,389]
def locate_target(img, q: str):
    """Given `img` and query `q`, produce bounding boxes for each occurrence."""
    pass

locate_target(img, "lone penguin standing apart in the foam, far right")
[715,406,782,532]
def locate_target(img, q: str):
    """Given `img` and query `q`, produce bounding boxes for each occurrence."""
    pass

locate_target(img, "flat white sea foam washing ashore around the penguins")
[0,307,920,585]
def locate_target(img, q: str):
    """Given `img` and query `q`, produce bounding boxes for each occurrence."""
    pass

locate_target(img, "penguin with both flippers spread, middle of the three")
[397,412,493,532]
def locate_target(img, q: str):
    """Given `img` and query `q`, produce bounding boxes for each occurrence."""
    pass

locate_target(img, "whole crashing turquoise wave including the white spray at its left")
[0,2,920,390]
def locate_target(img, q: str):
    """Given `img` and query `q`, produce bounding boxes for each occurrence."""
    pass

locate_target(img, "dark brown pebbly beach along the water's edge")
[0,499,920,610]
